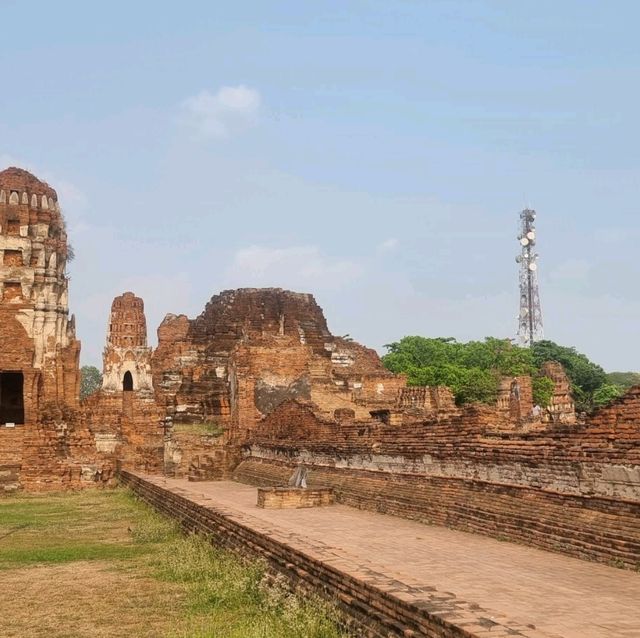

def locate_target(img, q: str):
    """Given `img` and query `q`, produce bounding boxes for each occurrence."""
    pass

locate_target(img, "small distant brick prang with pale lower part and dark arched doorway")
[102,292,153,393]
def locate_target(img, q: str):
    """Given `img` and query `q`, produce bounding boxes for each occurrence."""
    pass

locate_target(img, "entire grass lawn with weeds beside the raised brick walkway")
[0,489,343,638]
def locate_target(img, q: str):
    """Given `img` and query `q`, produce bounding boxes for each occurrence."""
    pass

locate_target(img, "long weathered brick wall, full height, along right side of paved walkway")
[235,396,640,567]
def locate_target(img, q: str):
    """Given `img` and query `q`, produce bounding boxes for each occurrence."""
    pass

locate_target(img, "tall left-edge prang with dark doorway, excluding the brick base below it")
[0,167,80,425]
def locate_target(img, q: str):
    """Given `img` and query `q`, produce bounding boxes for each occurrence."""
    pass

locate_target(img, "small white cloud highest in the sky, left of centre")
[182,84,261,138]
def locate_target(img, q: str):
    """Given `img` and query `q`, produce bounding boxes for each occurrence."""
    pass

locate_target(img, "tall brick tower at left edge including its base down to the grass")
[0,168,108,489]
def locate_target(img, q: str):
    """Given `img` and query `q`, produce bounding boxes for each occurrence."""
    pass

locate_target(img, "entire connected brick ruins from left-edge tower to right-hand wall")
[0,168,640,566]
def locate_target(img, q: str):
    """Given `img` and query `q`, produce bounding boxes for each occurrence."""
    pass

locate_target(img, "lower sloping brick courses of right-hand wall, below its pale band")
[234,459,640,569]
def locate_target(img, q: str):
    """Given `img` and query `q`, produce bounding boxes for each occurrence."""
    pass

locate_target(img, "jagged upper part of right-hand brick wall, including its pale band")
[247,398,640,503]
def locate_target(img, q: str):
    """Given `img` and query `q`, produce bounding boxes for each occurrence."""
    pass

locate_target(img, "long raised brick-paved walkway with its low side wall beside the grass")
[122,472,640,638]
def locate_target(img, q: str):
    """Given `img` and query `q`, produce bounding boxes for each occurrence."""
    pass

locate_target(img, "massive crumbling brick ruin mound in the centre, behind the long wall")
[152,288,406,440]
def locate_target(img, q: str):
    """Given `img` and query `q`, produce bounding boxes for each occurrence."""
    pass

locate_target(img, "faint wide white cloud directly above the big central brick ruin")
[225,246,364,292]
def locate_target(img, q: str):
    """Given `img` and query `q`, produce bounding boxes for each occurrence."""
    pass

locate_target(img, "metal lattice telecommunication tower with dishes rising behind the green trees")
[516,208,543,346]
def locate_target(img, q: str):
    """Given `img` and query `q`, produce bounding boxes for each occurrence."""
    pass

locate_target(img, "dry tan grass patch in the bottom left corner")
[0,561,185,638]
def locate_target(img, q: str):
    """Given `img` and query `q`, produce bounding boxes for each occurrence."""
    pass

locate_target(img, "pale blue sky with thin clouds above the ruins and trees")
[0,0,640,370]
